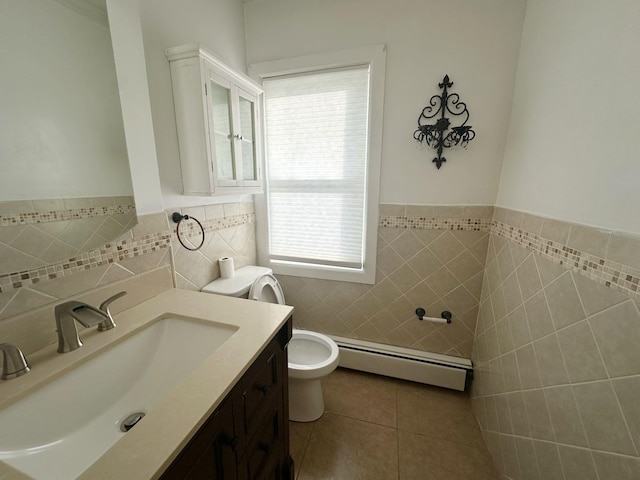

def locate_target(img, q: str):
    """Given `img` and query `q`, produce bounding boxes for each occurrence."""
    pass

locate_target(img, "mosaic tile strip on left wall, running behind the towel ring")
[0,213,255,293]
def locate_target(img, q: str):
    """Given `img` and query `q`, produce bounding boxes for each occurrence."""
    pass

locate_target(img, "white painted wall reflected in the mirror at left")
[0,0,133,201]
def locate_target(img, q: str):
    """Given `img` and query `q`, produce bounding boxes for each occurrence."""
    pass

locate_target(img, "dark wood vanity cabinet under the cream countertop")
[160,319,293,480]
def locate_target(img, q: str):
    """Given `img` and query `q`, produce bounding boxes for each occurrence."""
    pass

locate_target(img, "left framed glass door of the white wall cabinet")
[206,70,238,186]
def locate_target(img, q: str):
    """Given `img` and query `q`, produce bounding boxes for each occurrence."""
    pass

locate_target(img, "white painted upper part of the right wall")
[497,0,640,233]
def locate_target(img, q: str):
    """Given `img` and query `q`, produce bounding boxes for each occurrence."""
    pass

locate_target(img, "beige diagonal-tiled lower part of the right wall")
[472,208,640,480]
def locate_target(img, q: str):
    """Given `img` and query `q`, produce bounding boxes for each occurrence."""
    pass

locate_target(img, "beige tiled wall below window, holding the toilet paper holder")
[278,205,493,358]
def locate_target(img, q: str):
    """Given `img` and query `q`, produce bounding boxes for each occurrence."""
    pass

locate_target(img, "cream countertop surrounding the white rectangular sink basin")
[0,289,293,480]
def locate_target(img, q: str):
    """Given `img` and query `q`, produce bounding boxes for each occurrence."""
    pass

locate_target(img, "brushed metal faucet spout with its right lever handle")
[55,292,127,353]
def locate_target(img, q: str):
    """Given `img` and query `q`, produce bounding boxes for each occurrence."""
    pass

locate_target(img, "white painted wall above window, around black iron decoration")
[245,0,525,204]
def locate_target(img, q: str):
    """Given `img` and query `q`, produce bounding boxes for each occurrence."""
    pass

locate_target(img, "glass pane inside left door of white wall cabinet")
[209,79,236,185]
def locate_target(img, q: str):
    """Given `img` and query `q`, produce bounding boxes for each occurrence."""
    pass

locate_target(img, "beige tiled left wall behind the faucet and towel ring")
[0,203,256,363]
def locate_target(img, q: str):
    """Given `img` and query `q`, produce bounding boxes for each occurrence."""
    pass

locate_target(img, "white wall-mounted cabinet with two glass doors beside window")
[166,45,263,195]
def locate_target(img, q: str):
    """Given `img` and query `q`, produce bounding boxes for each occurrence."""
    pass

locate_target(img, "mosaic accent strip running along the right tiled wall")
[492,221,640,296]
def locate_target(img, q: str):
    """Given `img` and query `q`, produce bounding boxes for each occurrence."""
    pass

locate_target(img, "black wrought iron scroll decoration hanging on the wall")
[413,75,476,169]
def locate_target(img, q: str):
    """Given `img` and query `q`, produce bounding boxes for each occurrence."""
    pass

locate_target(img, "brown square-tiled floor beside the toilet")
[290,369,498,480]
